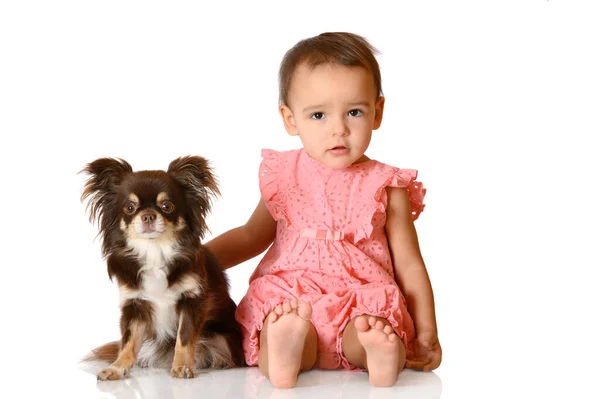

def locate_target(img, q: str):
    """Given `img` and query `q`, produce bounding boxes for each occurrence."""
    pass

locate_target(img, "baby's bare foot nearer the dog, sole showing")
[267,299,312,388]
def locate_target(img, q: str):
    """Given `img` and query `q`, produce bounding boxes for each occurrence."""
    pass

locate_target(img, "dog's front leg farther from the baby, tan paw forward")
[98,299,152,381]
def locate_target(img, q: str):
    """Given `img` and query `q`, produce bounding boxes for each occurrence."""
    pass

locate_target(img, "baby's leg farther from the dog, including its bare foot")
[342,316,406,387]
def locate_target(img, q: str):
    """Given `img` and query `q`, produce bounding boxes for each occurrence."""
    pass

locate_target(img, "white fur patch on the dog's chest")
[119,240,200,341]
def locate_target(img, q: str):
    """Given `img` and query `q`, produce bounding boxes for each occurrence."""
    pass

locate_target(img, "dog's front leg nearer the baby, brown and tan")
[171,298,205,378]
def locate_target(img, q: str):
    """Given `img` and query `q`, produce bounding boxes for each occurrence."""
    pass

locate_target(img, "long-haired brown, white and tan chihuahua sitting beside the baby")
[81,156,244,380]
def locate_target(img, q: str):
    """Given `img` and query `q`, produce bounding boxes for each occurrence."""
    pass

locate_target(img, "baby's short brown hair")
[279,32,383,105]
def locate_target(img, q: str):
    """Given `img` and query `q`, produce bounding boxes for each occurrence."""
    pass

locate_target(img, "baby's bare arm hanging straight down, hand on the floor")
[385,187,441,370]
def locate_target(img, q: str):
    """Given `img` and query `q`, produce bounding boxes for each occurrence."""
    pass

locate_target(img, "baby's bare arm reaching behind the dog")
[206,199,277,269]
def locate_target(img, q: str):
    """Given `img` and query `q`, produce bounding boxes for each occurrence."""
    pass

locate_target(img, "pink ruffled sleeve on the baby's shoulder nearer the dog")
[258,149,289,222]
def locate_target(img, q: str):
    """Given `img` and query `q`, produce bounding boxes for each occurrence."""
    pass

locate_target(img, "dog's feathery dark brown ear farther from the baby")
[79,158,133,232]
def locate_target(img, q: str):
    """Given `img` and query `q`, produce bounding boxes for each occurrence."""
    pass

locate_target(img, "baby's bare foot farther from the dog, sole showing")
[354,316,406,387]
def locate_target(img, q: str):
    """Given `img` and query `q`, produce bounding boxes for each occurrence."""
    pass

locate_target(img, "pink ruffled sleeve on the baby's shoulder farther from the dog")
[354,167,427,243]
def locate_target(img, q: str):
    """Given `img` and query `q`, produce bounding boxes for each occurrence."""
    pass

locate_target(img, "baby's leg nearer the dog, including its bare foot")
[258,299,317,388]
